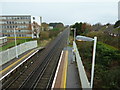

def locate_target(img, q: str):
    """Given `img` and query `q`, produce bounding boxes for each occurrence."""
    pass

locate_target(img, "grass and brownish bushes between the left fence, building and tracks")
[0,23,64,51]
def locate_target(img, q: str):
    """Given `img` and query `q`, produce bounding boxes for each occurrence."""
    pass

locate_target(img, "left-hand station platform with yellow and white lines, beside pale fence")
[0,47,43,80]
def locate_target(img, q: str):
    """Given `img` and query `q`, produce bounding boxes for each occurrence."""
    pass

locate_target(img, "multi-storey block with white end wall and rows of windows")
[0,15,40,38]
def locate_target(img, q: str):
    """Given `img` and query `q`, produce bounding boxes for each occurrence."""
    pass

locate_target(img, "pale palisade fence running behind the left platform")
[0,40,37,65]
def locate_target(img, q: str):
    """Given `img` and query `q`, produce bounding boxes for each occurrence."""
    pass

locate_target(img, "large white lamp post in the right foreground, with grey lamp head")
[76,36,97,88]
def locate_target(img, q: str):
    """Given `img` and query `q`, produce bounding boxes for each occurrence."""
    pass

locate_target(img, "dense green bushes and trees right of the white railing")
[71,22,120,90]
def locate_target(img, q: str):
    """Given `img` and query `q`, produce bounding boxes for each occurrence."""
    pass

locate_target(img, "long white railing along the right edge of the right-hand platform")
[73,41,91,90]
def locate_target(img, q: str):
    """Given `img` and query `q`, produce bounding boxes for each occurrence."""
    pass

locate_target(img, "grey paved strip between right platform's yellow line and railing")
[66,47,81,89]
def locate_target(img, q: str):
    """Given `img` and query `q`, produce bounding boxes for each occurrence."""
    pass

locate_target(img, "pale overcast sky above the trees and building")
[0,0,119,24]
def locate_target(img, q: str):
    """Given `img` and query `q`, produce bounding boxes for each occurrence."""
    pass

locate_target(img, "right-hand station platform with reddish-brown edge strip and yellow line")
[52,47,81,89]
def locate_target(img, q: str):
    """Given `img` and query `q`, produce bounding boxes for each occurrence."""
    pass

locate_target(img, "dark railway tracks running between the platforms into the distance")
[3,30,69,90]
